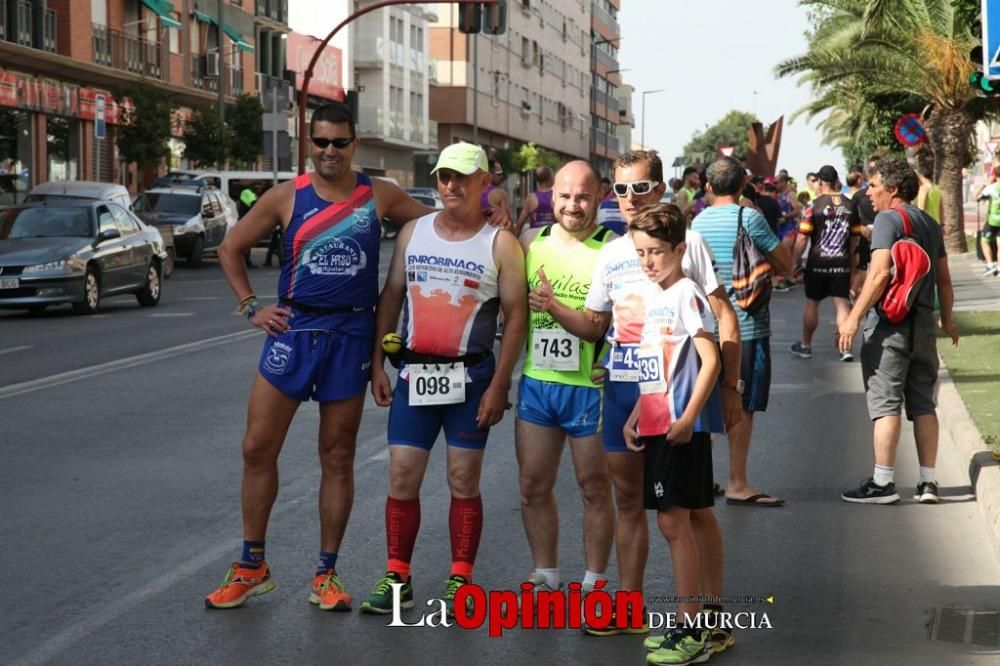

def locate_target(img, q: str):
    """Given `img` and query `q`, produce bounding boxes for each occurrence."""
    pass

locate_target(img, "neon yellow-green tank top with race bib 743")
[524,225,611,388]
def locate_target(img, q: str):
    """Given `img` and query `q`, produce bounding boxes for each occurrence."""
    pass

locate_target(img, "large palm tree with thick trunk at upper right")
[777,0,996,252]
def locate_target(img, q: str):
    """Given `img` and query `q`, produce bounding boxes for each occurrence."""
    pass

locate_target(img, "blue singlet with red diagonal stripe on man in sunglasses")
[278,173,382,336]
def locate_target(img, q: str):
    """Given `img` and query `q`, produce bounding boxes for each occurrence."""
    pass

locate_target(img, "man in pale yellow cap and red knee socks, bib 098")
[361,143,527,613]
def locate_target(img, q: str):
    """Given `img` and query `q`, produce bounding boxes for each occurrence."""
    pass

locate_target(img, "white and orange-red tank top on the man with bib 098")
[403,213,500,357]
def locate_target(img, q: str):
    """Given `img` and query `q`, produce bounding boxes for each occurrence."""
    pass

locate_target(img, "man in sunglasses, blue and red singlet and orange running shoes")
[205,103,452,611]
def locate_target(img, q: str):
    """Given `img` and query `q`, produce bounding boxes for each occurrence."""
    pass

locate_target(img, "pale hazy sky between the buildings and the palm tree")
[618,0,844,180]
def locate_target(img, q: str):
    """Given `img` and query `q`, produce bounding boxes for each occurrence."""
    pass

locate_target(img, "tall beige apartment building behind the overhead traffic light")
[430,0,592,176]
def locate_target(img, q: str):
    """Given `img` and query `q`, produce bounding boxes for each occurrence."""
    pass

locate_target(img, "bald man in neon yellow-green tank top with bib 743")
[515,161,615,590]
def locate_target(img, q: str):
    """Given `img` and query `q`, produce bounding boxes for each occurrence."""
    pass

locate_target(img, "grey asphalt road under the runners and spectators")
[0,243,1000,665]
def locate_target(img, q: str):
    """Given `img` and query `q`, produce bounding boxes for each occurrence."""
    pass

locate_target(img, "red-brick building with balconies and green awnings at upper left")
[0,0,288,187]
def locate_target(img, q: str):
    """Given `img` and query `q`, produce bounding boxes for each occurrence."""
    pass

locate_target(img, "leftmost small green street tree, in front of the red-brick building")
[115,81,171,171]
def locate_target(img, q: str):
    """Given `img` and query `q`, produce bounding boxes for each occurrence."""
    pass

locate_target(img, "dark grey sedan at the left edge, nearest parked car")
[0,201,167,314]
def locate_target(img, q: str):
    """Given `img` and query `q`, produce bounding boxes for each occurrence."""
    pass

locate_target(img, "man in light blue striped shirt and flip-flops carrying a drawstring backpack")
[692,157,792,507]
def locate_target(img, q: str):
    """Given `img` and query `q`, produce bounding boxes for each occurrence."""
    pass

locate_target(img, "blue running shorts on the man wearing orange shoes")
[258,330,372,402]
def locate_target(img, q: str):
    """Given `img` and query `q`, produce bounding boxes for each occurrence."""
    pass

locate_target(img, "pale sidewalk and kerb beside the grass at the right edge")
[938,252,1000,558]
